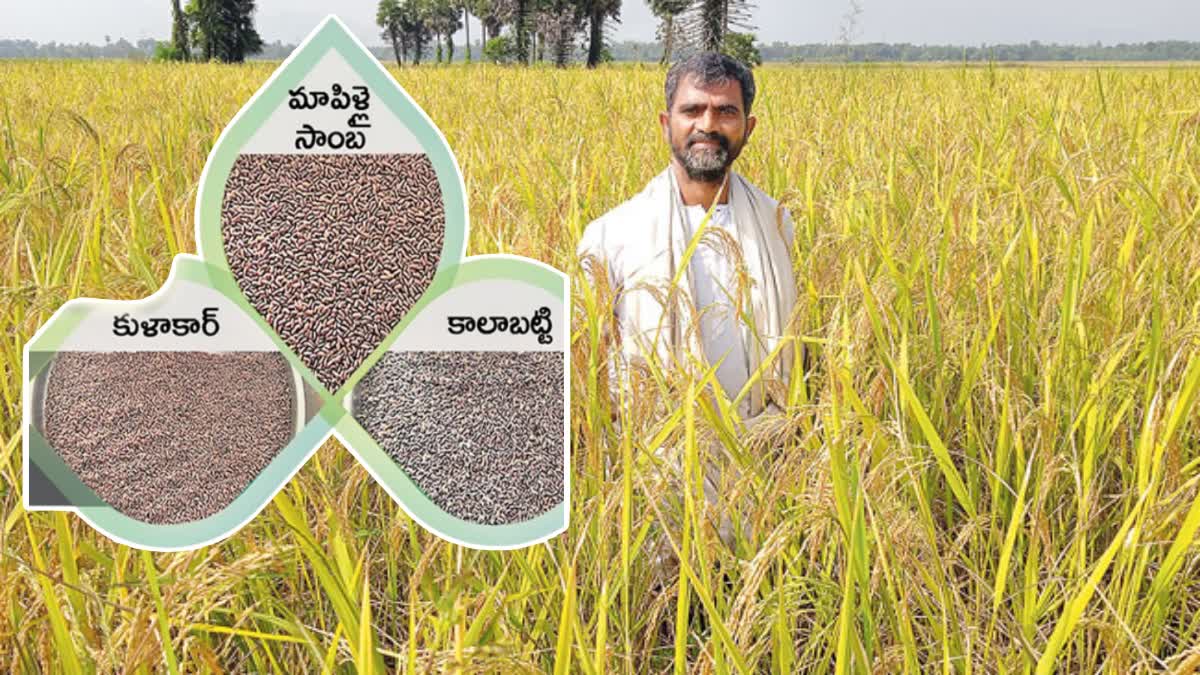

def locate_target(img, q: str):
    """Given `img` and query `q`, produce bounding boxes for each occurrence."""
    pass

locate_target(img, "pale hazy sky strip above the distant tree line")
[0,0,1200,46]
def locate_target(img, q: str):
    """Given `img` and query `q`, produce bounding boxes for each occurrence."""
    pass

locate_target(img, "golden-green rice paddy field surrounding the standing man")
[0,61,1200,674]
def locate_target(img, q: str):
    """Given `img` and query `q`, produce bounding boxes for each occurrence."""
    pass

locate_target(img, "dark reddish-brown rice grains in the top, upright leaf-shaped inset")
[221,155,445,390]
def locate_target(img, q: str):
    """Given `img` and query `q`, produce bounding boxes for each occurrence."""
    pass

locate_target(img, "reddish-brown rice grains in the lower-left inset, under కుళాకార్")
[43,352,295,524]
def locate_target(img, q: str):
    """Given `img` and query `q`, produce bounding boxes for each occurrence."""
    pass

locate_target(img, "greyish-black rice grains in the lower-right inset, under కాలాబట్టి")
[354,352,564,525]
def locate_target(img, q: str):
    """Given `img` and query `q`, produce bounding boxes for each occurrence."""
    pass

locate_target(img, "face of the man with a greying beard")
[659,76,757,183]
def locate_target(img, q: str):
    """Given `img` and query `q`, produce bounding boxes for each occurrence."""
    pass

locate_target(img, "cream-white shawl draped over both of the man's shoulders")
[578,167,796,416]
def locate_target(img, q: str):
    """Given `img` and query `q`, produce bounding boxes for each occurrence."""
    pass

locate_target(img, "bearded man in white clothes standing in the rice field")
[578,53,796,418]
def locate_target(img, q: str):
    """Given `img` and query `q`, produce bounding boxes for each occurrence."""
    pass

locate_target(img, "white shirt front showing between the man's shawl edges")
[684,204,750,399]
